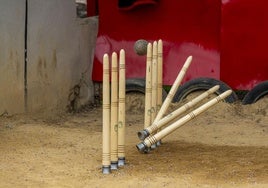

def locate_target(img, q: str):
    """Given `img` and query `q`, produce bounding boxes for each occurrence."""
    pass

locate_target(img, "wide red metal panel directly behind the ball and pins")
[92,0,221,85]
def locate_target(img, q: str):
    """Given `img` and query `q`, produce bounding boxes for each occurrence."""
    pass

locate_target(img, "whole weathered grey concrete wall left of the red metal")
[0,0,98,114]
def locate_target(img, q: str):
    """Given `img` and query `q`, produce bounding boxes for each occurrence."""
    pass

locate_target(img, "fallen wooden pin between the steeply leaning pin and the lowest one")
[138,85,220,140]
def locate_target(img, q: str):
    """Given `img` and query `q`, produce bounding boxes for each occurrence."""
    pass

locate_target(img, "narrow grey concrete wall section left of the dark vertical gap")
[0,0,25,115]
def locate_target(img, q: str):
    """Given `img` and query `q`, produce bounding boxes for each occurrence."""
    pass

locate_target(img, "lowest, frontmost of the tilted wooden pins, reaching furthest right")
[136,90,232,153]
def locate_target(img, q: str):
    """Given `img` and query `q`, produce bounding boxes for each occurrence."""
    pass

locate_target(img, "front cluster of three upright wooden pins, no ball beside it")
[102,49,126,174]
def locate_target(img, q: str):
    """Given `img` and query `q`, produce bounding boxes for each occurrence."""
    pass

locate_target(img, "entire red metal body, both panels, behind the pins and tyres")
[88,0,268,103]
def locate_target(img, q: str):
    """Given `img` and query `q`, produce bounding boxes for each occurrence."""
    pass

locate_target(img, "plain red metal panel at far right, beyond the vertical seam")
[221,0,268,90]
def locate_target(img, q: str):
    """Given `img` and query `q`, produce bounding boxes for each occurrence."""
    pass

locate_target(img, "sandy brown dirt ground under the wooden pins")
[0,94,268,188]
